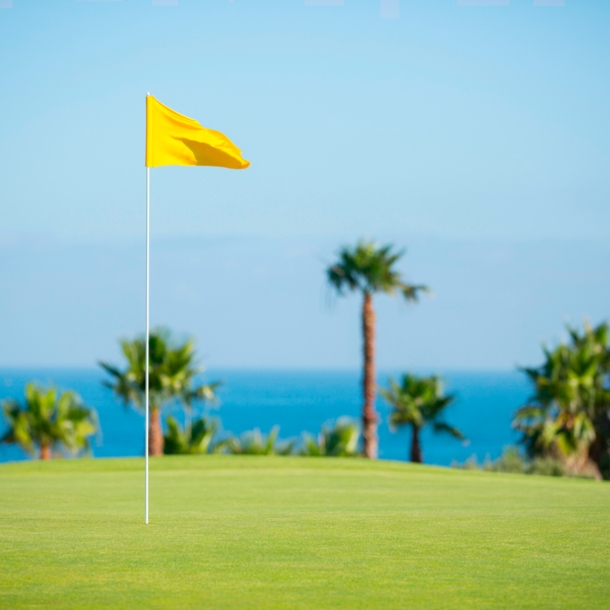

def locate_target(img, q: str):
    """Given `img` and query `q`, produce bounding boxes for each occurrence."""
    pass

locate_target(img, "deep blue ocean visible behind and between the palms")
[0,369,530,466]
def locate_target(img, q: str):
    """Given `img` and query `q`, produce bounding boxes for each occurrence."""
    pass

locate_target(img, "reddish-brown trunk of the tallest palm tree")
[362,292,377,459]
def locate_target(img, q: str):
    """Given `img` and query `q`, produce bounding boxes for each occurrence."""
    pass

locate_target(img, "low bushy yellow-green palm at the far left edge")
[0,383,99,460]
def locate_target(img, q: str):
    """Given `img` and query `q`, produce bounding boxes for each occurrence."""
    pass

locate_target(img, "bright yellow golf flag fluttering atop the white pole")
[146,95,250,169]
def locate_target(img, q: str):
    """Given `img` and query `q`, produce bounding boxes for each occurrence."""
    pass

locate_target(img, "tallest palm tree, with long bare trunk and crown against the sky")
[326,241,427,458]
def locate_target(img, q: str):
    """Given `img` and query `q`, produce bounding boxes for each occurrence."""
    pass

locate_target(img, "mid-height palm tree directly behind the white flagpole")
[100,329,219,456]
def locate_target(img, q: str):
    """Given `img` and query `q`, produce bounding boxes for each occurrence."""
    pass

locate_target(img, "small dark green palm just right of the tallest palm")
[379,374,465,464]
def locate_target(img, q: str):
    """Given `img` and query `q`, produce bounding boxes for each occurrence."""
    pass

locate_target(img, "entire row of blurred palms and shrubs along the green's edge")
[0,241,610,479]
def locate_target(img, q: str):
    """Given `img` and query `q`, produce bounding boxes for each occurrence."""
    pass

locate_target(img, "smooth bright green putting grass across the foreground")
[0,456,610,610]
